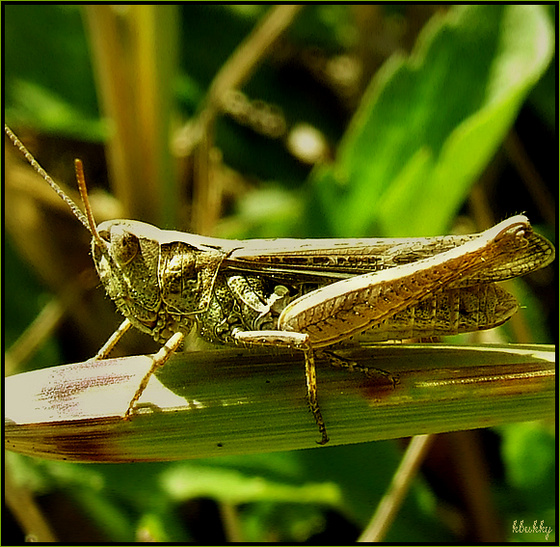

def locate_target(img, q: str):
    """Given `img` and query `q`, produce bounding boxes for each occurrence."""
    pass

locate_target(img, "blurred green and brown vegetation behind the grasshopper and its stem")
[2,4,558,543]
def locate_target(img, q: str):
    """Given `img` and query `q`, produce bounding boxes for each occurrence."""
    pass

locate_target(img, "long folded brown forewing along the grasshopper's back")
[222,219,554,287]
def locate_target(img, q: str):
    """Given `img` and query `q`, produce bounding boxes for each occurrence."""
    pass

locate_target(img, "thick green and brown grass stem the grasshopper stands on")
[5,345,555,462]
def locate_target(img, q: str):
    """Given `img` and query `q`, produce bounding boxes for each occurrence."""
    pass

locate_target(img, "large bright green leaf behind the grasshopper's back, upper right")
[313,5,554,236]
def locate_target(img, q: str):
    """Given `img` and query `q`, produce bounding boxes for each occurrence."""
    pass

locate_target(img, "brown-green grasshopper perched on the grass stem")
[5,126,554,445]
